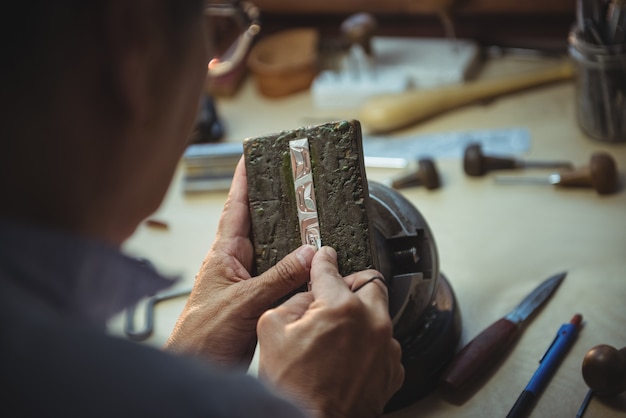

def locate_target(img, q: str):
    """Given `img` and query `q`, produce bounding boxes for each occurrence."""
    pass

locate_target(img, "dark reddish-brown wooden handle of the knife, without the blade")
[441,318,520,391]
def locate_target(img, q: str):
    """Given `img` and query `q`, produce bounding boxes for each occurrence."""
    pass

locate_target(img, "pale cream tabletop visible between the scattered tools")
[111,55,626,417]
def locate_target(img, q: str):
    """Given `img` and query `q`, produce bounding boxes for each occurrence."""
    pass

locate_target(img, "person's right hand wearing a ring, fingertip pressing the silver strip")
[258,247,404,418]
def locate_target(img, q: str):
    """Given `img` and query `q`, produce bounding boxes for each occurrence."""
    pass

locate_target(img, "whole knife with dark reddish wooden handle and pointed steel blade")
[441,272,567,392]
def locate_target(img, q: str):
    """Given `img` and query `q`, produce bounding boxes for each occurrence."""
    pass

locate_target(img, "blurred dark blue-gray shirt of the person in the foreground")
[0,220,304,417]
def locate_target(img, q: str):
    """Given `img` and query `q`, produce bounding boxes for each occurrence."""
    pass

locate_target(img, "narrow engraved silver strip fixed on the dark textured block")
[289,138,322,248]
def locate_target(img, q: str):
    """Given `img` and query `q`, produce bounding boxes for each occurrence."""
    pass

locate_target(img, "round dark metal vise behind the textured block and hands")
[368,182,461,412]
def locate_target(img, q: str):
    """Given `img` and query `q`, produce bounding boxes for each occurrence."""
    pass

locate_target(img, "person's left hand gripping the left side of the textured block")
[165,158,316,367]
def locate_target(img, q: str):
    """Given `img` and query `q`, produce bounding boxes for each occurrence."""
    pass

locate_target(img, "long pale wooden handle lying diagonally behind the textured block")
[359,61,574,132]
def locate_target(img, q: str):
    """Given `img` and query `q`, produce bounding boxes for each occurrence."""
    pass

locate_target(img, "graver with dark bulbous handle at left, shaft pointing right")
[463,143,572,177]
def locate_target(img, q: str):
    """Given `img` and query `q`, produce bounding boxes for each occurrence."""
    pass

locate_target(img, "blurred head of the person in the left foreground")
[0,0,209,243]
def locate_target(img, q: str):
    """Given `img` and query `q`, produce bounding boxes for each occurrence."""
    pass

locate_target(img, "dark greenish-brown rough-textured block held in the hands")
[244,121,376,276]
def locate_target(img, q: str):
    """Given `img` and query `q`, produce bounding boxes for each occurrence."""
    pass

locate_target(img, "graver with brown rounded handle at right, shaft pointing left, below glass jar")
[495,152,619,194]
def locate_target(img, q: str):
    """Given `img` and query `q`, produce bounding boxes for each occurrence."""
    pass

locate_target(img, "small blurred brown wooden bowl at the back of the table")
[248,28,319,97]
